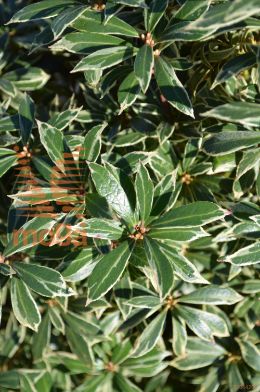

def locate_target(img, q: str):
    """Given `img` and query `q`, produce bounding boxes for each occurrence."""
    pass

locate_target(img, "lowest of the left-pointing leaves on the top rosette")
[71,45,136,73]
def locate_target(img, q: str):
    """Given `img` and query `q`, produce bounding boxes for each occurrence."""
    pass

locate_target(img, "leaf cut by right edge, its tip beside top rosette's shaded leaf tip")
[201,102,260,127]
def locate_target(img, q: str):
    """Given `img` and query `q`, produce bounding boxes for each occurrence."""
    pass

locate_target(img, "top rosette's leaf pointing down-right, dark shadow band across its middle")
[155,57,194,118]
